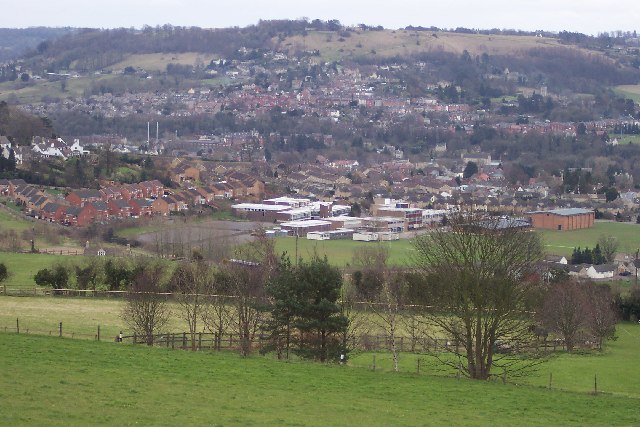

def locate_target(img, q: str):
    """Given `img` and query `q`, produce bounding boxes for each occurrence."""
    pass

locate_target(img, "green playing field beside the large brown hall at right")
[540,221,640,256]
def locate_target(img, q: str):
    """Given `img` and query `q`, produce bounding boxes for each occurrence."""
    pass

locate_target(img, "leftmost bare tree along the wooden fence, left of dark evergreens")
[122,262,171,345]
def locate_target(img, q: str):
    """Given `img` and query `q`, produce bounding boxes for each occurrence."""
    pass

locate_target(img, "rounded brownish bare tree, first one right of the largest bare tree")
[538,280,588,351]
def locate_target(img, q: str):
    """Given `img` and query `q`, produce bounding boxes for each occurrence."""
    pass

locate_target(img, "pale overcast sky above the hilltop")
[5,0,640,35]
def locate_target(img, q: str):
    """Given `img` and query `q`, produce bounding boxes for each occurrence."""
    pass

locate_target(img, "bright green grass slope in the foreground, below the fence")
[0,333,640,426]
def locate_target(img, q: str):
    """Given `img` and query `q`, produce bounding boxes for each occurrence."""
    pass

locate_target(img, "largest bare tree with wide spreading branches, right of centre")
[414,212,543,379]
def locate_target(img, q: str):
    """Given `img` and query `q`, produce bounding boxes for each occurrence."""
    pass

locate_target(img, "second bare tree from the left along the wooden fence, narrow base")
[171,260,213,351]
